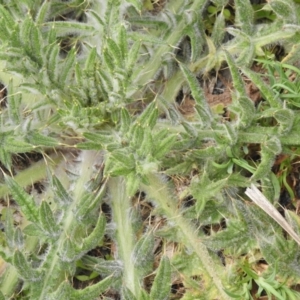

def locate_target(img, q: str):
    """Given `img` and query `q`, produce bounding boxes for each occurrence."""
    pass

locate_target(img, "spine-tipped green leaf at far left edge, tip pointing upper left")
[4,175,39,224]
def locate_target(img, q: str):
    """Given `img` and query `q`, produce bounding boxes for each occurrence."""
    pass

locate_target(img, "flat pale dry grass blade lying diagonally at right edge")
[245,184,300,245]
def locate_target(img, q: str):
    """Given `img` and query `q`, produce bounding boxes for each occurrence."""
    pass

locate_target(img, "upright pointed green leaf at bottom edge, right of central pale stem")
[150,256,171,300]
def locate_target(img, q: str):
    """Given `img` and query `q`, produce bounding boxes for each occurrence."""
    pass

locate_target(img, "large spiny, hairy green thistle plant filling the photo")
[0,0,300,300]
